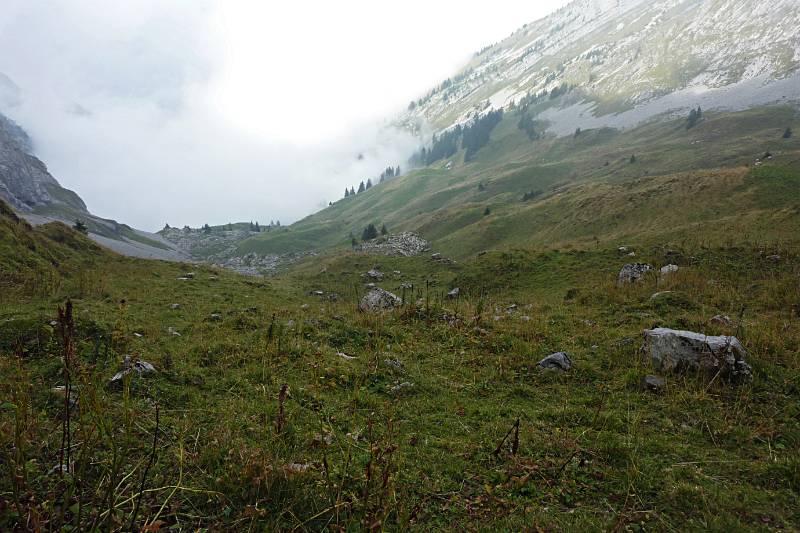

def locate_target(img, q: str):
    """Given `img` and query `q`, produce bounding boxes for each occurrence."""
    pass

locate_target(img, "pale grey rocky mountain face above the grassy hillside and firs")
[403,0,800,135]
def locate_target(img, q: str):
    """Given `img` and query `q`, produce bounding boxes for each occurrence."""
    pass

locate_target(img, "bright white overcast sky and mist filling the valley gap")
[0,0,567,230]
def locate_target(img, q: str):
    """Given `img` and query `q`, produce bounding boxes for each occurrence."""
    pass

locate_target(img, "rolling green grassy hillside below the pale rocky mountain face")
[238,106,800,257]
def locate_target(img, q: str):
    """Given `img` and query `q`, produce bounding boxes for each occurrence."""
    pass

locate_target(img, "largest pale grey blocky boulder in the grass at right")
[644,328,752,379]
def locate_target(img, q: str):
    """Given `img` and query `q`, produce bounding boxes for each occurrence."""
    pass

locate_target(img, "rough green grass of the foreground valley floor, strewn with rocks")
[0,238,800,531]
